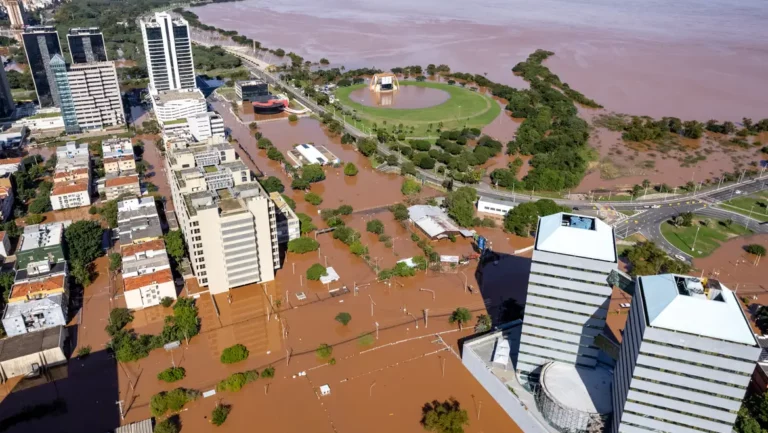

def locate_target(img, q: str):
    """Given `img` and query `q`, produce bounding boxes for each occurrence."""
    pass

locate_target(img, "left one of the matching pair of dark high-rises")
[22,26,61,108]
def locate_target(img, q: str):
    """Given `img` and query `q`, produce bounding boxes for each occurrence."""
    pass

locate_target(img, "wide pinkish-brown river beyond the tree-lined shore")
[192,0,768,121]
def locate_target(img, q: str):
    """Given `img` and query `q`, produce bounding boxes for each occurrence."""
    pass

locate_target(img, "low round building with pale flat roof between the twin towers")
[536,362,613,432]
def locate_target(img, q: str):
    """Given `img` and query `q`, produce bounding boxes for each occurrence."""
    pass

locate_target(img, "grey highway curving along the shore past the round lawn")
[200,41,768,259]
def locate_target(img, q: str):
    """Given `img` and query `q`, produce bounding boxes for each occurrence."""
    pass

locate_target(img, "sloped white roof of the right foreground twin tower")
[638,274,757,346]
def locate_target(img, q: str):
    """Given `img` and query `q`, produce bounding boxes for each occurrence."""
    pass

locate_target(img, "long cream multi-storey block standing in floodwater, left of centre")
[166,134,280,293]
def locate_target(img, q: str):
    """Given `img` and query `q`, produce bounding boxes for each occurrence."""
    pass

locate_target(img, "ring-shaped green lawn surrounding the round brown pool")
[336,81,501,137]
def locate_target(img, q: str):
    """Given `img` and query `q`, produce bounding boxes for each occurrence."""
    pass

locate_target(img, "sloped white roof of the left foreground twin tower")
[536,212,617,263]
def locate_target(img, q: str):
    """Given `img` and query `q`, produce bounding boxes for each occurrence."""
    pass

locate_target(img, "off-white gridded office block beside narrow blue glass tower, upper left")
[67,62,125,131]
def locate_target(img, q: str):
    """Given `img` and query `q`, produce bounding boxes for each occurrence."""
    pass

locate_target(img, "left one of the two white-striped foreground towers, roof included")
[517,213,617,378]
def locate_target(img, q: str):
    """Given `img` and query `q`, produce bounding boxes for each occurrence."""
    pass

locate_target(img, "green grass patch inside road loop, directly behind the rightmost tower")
[661,217,752,257]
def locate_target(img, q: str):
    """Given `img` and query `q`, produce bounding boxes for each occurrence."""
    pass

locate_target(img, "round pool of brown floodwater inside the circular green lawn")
[349,86,451,108]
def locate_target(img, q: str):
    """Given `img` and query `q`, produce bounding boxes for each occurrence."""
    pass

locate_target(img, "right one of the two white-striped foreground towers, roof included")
[612,274,761,433]
